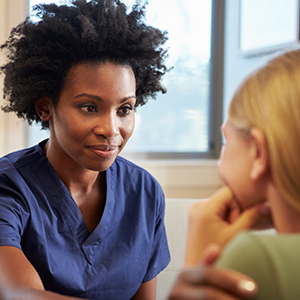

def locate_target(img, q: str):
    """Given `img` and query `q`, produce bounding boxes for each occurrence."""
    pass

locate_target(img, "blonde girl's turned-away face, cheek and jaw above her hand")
[219,121,261,208]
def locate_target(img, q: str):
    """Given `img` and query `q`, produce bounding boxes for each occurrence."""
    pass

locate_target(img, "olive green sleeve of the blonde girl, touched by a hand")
[216,232,283,300]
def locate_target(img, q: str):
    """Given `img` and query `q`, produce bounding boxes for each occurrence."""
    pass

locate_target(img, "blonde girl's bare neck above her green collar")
[267,183,300,233]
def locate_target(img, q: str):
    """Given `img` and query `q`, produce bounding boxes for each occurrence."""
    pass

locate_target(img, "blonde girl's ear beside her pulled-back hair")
[250,128,269,180]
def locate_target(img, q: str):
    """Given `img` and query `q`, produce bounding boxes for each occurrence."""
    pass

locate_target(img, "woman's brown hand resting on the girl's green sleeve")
[168,245,257,300]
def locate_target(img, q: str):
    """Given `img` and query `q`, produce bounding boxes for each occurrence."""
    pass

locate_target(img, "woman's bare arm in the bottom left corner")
[0,246,84,300]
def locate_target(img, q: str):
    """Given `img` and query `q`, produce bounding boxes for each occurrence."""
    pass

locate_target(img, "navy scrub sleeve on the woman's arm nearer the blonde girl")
[143,185,170,282]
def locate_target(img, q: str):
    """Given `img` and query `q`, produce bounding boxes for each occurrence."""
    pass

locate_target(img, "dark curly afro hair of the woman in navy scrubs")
[1,0,168,128]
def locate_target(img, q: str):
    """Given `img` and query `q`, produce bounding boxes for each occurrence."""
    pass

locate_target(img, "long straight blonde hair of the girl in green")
[229,50,300,210]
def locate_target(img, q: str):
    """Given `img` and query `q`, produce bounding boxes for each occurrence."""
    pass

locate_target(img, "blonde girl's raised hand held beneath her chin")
[185,187,271,266]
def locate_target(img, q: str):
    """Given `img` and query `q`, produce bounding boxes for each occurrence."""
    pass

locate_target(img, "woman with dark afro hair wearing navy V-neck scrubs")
[0,0,170,299]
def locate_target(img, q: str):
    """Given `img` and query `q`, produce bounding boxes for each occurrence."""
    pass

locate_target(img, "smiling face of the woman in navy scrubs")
[47,62,136,171]
